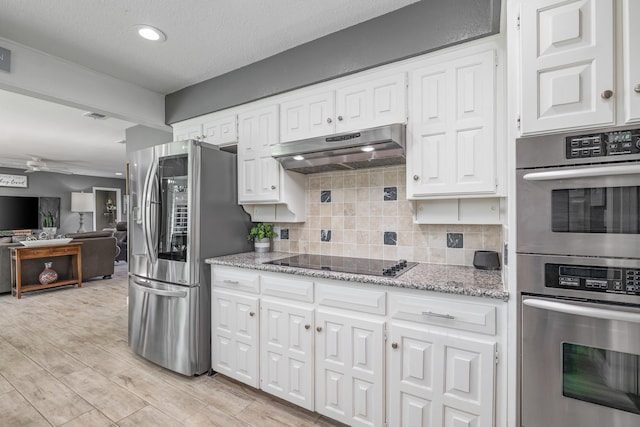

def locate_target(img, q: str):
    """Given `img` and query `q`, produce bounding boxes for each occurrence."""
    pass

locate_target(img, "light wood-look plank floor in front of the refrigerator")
[0,263,342,427]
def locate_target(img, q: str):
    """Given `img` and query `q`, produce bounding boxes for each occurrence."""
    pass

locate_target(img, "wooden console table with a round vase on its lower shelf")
[10,243,82,298]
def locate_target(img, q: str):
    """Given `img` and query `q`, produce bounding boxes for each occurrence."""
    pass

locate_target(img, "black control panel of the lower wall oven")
[545,264,640,295]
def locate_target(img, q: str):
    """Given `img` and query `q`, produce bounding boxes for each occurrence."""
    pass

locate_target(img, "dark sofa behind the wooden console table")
[0,231,118,293]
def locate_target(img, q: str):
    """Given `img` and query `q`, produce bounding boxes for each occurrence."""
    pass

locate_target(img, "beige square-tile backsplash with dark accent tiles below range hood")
[274,166,503,265]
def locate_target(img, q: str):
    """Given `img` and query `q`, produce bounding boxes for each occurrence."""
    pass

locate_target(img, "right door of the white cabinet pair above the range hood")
[336,73,407,132]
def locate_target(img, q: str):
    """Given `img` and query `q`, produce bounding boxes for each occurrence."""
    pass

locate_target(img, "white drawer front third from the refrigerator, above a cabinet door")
[316,283,387,315]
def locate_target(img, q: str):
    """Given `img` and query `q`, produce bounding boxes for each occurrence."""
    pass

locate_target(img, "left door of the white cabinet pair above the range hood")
[280,91,335,142]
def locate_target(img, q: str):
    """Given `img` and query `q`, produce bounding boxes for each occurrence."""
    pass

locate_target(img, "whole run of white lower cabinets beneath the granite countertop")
[212,266,506,427]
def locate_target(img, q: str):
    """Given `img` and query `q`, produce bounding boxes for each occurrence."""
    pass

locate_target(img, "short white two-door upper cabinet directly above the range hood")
[280,72,407,142]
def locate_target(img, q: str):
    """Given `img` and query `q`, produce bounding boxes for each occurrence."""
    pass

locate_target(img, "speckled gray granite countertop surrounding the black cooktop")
[206,252,509,301]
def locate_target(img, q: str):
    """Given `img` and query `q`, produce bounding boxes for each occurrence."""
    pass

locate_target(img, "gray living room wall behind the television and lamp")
[0,168,125,234]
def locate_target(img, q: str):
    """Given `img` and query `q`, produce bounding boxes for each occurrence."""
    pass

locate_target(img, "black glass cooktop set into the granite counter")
[266,254,417,277]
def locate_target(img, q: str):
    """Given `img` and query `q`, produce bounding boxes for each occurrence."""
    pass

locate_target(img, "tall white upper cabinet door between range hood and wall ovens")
[407,50,496,197]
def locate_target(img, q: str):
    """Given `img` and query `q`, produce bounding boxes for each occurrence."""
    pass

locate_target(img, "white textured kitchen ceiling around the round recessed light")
[0,0,417,94]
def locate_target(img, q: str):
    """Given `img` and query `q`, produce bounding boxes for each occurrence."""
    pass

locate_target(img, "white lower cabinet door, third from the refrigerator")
[316,309,385,426]
